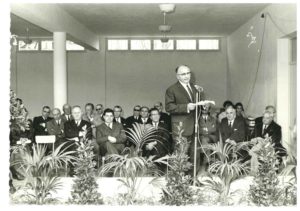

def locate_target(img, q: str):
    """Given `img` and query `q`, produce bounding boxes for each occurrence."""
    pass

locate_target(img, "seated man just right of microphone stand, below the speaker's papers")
[197,104,218,172]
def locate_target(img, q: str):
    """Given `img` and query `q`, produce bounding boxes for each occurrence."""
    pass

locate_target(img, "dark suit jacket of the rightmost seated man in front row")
[253,121,286,156]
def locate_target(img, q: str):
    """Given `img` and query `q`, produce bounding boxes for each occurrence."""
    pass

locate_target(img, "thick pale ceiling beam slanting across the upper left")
[11,3,100,50]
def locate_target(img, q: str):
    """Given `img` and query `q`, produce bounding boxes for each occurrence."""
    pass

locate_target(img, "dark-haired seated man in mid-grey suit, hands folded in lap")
[96,108,126,156]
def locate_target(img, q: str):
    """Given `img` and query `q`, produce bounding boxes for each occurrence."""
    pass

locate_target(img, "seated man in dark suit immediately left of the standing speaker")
[143,108,172,157]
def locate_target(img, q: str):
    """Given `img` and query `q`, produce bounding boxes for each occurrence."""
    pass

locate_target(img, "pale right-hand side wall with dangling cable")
[228,4,297,116]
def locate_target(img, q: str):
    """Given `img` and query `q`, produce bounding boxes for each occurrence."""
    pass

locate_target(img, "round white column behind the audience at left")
[53,32,68,109]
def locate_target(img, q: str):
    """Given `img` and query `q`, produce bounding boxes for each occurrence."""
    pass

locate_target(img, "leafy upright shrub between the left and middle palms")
[69,140,103,204]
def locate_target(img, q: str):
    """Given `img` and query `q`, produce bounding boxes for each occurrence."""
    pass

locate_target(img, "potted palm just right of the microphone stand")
[203,141,249,204]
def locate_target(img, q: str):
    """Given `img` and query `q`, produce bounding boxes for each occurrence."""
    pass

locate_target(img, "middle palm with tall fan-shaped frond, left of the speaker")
[100,124,168,204]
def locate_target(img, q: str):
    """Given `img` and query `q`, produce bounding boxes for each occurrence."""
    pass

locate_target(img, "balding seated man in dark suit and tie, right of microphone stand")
[218,106,245,143]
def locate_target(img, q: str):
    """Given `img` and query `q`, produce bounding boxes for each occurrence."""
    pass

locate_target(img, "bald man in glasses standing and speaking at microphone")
[165,65,202,171]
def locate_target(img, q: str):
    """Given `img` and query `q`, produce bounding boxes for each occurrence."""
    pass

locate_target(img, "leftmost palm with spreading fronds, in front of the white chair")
[11,143,75,204]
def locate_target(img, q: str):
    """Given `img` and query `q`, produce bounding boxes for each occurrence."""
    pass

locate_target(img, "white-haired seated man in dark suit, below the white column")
[64,106,93,176]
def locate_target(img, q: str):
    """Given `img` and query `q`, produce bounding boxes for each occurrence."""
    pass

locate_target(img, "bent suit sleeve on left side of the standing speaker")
[165,89,188,114]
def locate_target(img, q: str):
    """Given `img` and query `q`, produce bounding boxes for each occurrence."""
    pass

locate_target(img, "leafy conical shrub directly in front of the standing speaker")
[161,126,196,206]
